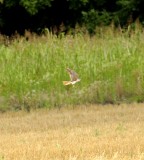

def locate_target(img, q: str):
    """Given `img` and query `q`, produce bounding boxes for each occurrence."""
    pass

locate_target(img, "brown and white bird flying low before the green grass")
[63,68,80,86]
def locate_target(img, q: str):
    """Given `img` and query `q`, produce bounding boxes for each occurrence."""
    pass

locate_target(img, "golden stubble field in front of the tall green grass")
[0,104,144,160]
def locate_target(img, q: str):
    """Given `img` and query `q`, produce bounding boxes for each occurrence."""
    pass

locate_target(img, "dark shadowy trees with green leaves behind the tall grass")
[0,0,144,35]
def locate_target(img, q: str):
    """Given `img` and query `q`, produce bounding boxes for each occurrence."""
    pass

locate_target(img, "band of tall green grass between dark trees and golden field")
[0,24,144,111]
